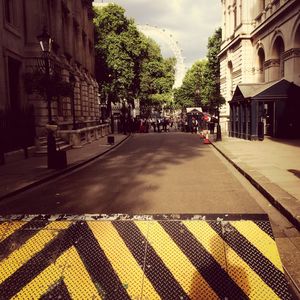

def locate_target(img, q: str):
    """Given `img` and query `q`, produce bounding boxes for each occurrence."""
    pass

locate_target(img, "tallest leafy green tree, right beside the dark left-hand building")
[94,4,142,115]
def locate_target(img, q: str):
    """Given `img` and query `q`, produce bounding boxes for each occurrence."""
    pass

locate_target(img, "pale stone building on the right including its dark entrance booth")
[219,0,300,139]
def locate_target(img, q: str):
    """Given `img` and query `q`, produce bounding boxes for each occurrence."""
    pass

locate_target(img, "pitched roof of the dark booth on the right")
[231,79,300,102]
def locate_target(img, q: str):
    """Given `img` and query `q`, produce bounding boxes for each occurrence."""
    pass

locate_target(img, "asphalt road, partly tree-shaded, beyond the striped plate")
[0,132,264,215]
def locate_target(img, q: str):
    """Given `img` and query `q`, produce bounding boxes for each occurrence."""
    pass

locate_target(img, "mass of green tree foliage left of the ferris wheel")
[94,4,175,114]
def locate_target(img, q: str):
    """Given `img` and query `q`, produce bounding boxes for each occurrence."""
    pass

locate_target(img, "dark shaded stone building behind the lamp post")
[0,0,105,155]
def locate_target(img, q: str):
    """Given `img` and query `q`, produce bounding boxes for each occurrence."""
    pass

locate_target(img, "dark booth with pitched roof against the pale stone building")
[229,79,300,140]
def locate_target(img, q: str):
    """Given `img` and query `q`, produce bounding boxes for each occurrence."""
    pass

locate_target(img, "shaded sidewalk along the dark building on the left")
[0,134,129,200]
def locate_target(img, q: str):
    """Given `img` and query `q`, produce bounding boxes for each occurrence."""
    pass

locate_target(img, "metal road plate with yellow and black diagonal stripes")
[0,215,292,300]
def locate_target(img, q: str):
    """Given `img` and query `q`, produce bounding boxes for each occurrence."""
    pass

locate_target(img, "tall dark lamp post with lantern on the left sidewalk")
[37,27,57,169]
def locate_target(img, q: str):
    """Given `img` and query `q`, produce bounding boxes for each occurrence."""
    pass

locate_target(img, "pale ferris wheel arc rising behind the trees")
[137,24,186,87]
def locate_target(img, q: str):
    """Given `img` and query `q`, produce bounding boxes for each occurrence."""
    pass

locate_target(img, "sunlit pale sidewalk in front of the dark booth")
[212,137,300,230]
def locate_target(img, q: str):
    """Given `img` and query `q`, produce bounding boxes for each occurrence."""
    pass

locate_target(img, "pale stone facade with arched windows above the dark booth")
[219,0,300,129]
